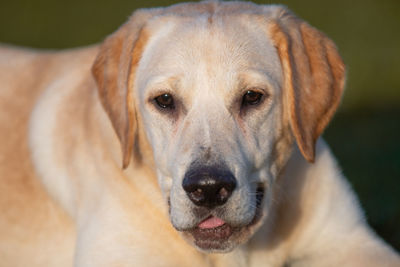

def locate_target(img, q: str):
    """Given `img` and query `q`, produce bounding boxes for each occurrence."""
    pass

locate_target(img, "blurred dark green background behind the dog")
[0,0,400,250]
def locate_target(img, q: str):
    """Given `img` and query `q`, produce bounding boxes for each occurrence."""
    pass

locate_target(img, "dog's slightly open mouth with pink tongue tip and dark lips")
[184,185,264,252]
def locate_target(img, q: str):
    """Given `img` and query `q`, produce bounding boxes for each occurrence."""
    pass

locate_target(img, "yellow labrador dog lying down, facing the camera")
[0,1,400,267]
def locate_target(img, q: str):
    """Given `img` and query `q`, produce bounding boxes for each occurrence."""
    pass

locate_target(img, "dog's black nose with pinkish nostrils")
[182,167,236,208]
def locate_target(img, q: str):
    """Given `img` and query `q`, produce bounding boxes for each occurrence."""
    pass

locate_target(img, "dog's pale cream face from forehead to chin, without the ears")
[137,16,283,251]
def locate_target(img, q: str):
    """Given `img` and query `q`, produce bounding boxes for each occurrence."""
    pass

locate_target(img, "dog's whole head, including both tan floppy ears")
[93,2,344,252]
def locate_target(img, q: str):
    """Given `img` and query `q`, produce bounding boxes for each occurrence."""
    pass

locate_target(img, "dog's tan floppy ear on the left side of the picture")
[92,9,159,168]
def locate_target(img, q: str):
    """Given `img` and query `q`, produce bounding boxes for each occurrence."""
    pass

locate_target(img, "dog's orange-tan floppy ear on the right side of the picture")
[269,7,345,162]
